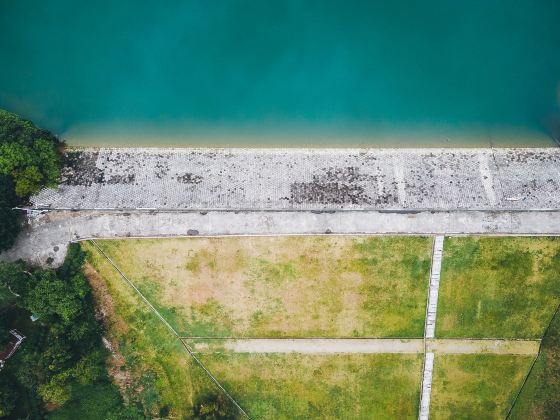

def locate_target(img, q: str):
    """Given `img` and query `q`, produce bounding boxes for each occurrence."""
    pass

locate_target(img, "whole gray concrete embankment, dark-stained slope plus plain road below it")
[4,148,560,266]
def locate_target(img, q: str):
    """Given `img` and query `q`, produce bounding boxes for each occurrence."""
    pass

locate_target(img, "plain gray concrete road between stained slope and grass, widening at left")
[0,211,560,265]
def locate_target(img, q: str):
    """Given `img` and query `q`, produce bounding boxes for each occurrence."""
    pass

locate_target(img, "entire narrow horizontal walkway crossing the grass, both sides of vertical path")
[186,337,540,355]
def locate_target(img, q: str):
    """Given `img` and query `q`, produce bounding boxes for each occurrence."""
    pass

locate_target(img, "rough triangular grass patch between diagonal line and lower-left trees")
[83,243,223,418]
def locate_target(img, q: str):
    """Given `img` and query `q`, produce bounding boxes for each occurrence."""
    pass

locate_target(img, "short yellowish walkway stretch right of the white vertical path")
[426,339,540,356]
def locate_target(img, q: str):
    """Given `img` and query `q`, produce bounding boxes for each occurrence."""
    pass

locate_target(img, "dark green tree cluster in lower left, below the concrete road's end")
[0,244,140,419]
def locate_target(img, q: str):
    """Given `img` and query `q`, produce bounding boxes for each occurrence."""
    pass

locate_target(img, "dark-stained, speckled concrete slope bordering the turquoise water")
[32,148,560,211]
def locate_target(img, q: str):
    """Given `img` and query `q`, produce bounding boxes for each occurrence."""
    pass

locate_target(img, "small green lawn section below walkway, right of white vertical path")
[430,354,533,420]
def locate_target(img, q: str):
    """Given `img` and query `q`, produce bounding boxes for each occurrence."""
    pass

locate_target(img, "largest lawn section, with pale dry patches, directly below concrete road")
[86,236,432,337]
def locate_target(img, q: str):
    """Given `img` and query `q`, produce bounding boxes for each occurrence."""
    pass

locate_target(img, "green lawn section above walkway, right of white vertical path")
[436,237,560,338]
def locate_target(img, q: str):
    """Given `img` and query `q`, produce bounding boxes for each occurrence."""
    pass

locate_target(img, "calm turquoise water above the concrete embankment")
[0,0,560,146]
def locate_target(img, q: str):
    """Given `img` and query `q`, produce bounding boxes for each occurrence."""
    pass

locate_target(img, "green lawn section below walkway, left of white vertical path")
[200,353,422,419]
